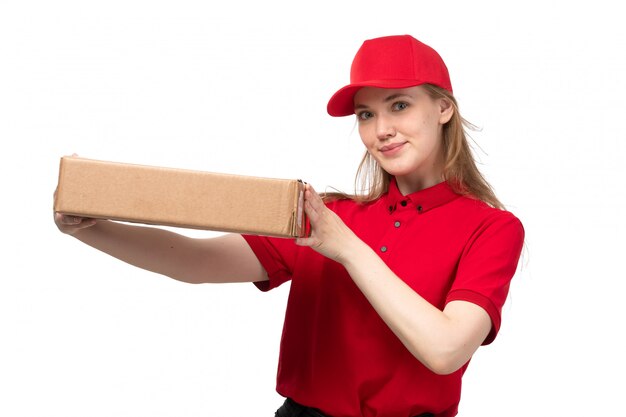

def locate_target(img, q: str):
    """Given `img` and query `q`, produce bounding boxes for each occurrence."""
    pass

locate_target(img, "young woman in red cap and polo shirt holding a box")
[55,35,524,417]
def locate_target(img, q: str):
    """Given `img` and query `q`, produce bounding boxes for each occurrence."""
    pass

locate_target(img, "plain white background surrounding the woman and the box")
[0,0,626,417]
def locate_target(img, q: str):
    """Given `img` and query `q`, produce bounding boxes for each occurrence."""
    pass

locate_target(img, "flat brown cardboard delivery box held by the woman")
[54,157,308,238]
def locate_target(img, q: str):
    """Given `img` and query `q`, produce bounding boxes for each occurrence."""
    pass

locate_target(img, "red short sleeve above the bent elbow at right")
[446,211,524,345]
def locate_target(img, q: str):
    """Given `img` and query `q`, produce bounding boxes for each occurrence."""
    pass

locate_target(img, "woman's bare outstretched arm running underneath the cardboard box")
[54,213,267,284]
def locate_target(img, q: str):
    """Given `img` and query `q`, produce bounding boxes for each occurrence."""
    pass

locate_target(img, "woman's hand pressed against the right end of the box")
[296,184,363,263]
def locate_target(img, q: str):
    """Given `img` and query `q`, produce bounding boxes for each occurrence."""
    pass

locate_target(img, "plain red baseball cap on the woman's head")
[327,35,452,116]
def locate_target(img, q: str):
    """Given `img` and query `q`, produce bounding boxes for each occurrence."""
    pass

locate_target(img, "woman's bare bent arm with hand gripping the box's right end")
[296,186,491,374]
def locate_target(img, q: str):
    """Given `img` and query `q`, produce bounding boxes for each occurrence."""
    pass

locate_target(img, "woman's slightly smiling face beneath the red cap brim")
[354,86,454,194]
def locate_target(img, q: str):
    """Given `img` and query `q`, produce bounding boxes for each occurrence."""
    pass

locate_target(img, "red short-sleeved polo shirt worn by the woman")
[244,181,524,417]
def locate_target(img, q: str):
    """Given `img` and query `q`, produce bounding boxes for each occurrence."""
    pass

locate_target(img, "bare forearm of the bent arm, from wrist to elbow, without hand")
[343,240,489,374]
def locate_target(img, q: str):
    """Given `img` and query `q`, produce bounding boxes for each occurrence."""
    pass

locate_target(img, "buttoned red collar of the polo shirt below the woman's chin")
[385,178,460,214]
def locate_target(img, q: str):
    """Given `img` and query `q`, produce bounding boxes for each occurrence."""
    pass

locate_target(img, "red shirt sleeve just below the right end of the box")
[242,235,298,291]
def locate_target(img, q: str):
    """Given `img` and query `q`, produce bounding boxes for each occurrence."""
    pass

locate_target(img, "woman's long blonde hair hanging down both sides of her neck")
[325,84,504,209]
